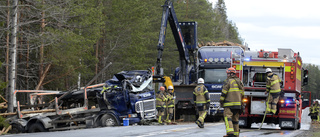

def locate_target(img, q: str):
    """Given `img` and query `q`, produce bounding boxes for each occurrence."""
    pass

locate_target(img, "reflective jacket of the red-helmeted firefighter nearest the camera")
[220,76,244,109]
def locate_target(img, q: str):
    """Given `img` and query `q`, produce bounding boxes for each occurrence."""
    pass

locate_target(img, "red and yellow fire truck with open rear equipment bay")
[238,48,310,129]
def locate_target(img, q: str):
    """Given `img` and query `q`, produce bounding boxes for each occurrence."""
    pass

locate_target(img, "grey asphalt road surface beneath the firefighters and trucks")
[4,108,311,137]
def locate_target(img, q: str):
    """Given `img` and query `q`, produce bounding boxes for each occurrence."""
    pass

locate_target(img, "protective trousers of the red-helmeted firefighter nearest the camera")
[223,108,240,137]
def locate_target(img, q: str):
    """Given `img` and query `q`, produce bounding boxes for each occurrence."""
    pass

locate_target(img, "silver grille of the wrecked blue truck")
[135,99,156,119]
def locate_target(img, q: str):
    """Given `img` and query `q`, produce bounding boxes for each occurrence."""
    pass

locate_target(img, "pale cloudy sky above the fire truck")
[208,0,320,65]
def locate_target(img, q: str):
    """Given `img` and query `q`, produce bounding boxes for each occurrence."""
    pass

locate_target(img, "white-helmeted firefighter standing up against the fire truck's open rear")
[265,68,281,114]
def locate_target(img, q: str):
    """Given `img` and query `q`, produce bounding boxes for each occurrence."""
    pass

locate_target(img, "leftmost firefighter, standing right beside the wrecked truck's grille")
[156,86,167,124]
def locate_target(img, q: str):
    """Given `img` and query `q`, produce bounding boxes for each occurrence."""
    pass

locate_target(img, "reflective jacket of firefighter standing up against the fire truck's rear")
[266,73,281,93]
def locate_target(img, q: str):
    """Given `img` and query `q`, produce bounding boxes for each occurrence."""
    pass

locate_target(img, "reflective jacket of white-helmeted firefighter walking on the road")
[193,84,210,104]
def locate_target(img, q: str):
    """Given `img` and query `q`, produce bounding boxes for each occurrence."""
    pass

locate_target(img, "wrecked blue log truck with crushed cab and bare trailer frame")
[6,70,156,133]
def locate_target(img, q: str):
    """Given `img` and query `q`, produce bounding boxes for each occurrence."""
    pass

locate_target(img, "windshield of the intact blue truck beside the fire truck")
[204,69,227,84]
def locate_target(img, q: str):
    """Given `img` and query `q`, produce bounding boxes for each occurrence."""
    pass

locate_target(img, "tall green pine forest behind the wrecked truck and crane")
[0,0,242,98]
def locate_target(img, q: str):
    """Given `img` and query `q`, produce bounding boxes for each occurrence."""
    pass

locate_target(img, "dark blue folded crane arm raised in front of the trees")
[154,0,197,85]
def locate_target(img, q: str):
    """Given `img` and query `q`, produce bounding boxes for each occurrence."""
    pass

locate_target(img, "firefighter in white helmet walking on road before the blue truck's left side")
[193,78,210,128]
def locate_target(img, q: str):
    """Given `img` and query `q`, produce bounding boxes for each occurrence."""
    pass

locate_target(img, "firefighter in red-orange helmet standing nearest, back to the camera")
[220,67,244,137]
